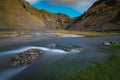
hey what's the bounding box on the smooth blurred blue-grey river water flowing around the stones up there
[0,36,120,80]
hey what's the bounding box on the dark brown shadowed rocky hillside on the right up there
[66,0,120,31]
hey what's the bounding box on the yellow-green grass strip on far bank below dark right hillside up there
[48,30,120,37]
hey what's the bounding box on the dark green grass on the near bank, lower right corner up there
[59,44,120,80]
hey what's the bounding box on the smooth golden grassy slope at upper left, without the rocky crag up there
[0,0,45,30]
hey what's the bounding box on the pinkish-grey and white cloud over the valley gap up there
[47,0,97,13]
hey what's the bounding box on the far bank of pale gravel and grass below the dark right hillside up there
[47,30,120,37]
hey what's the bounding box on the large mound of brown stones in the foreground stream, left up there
[11,49,43,66]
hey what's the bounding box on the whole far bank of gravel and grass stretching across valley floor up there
[0,30,120,47]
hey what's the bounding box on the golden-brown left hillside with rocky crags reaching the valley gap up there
[0,0,71,31]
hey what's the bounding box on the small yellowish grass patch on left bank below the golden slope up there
[0,31,25,38]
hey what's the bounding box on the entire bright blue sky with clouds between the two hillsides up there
[26,0,96,17]
